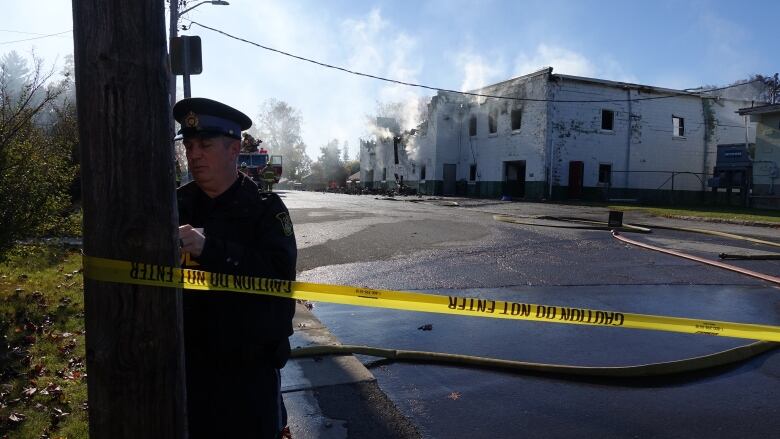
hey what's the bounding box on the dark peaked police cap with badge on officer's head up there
[173,98,252,140]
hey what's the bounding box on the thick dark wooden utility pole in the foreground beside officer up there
[73,0,187,439]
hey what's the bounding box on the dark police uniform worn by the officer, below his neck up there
[177,173,297,438]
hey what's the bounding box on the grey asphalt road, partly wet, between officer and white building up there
[282,192,780,438]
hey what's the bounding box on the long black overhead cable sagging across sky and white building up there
[189,20,757,103]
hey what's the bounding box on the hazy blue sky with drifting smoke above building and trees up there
[0,0,780,158]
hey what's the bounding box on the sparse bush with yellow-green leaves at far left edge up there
[0,52,77,257]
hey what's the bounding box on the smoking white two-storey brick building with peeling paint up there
[361,68,755,201]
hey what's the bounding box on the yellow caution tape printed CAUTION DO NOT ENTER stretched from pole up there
[84,256,780,342]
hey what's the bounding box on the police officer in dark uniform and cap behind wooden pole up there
[173,98,297,438]
